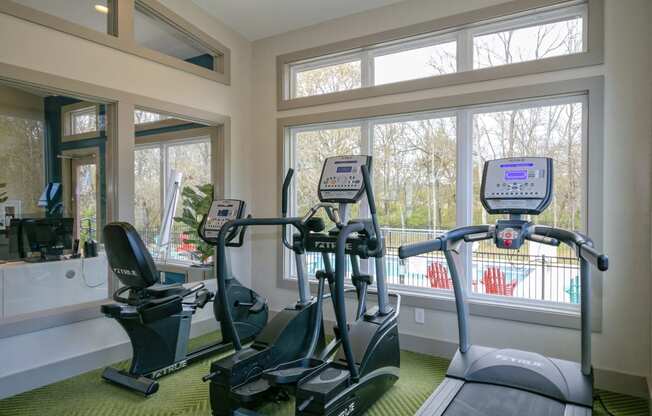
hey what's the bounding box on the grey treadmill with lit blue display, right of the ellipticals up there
[399,157,608,416]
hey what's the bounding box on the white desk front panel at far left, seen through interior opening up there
[0,253,109,319]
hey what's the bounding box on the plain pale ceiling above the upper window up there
[193,0,404,40]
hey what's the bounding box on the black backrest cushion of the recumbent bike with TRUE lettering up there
[104,222,160,289]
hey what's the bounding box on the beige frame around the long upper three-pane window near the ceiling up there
[276,0,604,111]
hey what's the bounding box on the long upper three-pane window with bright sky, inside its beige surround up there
[280,0,589,103]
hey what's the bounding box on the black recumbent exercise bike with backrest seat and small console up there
[101,200,268,396]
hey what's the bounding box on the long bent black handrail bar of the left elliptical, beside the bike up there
[217,217,301,351]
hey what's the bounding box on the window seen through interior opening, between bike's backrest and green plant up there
[134,137,212,262]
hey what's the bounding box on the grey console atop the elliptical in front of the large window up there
[317,155,371,204]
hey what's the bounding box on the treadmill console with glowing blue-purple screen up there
[480,157,552,215]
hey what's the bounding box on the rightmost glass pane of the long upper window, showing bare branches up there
[473,17,583,69]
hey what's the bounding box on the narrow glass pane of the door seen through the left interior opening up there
[77,164,97,247]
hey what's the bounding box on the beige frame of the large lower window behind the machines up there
[277,77,604,332]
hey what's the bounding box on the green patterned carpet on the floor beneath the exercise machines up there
[0,335,648,416]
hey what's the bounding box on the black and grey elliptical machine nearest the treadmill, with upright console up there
[295,156,401,416]
